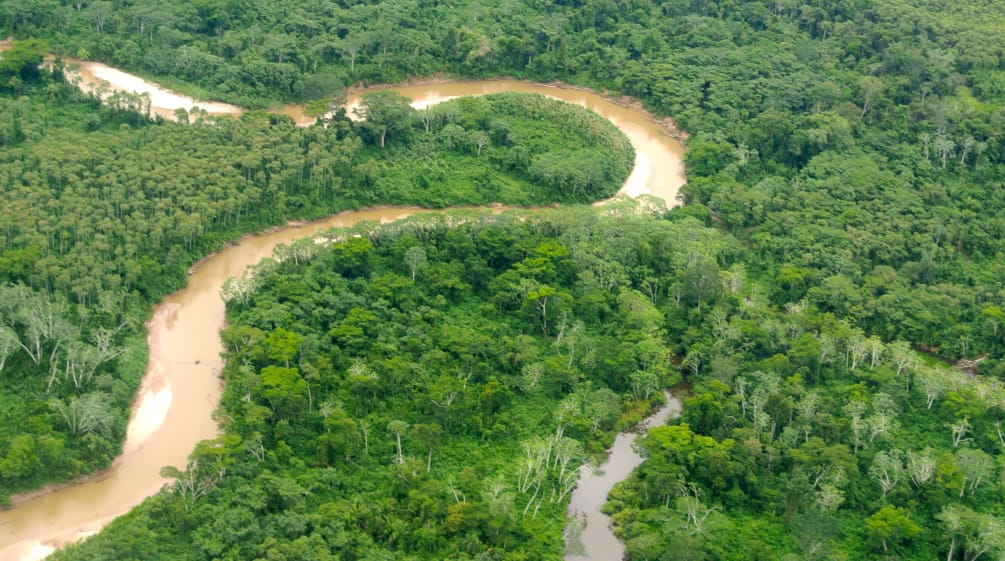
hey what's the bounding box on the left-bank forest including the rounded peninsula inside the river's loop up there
[0,65,632,496]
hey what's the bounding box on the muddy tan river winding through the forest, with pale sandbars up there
[0,53,684,561]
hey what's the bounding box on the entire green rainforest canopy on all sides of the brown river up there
[0,0,1005,561]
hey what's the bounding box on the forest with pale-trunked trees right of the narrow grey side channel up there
[607,267,1005,561]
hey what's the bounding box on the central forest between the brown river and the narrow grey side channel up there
[56,204,735,561]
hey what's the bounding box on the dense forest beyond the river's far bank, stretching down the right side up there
[2,0,1005,370]
